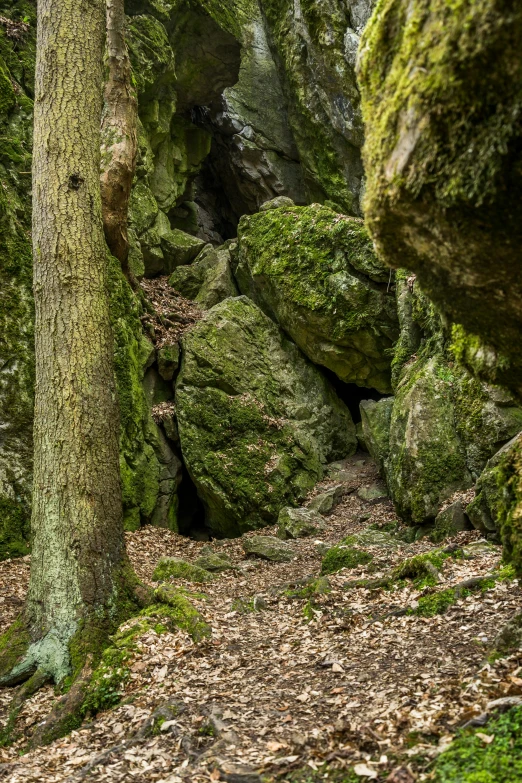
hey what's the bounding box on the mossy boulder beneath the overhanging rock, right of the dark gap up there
[361,275,522,525]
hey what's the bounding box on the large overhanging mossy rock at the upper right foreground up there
[359,0,522,396]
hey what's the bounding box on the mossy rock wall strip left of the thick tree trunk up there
[0,1,36,559]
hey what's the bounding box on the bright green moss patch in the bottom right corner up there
[433,707,522,783]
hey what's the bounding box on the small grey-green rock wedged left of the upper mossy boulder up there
[169,246,239,310]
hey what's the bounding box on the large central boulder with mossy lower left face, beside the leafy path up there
[176,297,356,536]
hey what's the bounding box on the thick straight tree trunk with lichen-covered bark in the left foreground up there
[23,0,126,682]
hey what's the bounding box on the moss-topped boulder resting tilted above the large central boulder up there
[235,204,399,392]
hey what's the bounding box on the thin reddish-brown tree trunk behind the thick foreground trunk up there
[100,0,138,283]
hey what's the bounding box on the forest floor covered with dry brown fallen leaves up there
[0,454,522,783]
